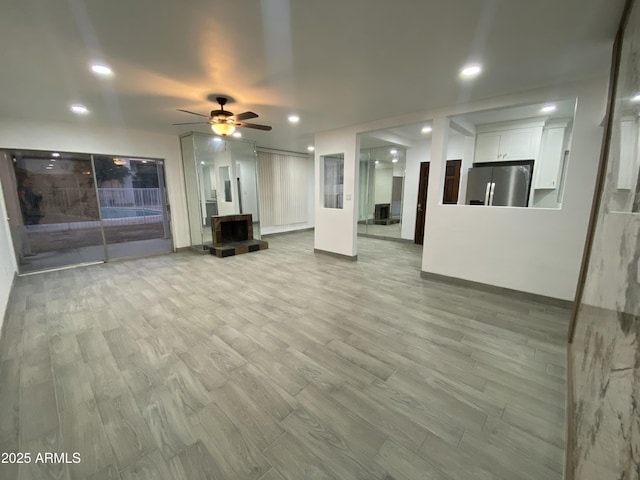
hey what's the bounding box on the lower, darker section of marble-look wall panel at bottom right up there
[570,305,640,480]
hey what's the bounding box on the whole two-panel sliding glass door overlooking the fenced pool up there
[0,150,173,274]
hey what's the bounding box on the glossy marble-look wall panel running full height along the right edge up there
[568,2,640,480]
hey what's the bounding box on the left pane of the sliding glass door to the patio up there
[2,150,105,273]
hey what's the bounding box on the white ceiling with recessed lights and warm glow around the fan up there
[0,0,624,151]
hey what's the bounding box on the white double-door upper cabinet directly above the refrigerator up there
[475,126,542,163]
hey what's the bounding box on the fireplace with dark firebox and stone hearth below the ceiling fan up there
[209,213,269,257]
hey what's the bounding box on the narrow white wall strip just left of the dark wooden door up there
[400,139,431,240]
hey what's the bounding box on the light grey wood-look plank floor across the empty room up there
[0,232,568,480]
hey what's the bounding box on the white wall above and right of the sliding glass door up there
[0,118,190,248]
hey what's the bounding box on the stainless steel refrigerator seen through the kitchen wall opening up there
[466,160,533,207]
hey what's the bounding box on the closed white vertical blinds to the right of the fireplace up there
[258,151,313,227]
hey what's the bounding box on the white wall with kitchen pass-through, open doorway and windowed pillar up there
[316,77,607,300]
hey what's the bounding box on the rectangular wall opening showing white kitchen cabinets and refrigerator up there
[442,99,576,208]
